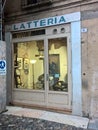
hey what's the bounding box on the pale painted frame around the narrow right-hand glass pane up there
[45,33,72,109]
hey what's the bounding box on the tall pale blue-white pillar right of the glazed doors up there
[71,21,82,116]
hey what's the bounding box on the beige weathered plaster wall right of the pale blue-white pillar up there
[81,18,98,117]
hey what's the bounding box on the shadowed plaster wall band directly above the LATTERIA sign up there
[4,0,98,25]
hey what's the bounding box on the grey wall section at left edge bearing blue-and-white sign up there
[0,41,6,113]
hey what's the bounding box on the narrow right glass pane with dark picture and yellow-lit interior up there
[48,38,68,91]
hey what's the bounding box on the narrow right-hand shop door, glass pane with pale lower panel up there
[47,37,71,109]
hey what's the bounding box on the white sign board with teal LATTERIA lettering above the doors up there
[12,12,80,31]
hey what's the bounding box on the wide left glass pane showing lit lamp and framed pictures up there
[14,40,44,90]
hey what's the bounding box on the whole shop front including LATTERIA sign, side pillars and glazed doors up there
[5,12,82,115]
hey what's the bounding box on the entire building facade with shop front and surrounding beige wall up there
[5,0,98,117]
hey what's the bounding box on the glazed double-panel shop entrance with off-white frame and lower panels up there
[12,34,71,110]
